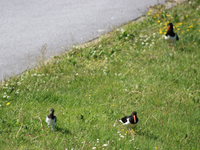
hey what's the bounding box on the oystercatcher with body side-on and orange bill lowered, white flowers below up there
[113,111,139,129]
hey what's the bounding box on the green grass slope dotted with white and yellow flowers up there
[0,0,200,150]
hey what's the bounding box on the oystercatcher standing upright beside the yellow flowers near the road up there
[165,22,179,52]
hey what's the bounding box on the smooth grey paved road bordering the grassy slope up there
[0,0,165,80]
